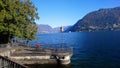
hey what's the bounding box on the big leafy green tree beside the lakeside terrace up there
[0,0,39,43]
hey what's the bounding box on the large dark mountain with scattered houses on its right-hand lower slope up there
[67,7,120,32]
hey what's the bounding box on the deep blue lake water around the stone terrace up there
[28,31,120,68]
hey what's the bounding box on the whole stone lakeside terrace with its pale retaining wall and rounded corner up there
[0,43,72,64]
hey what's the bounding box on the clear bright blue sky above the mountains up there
[31,0,120,28]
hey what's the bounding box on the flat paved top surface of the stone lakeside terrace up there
[11,47,72,56]
